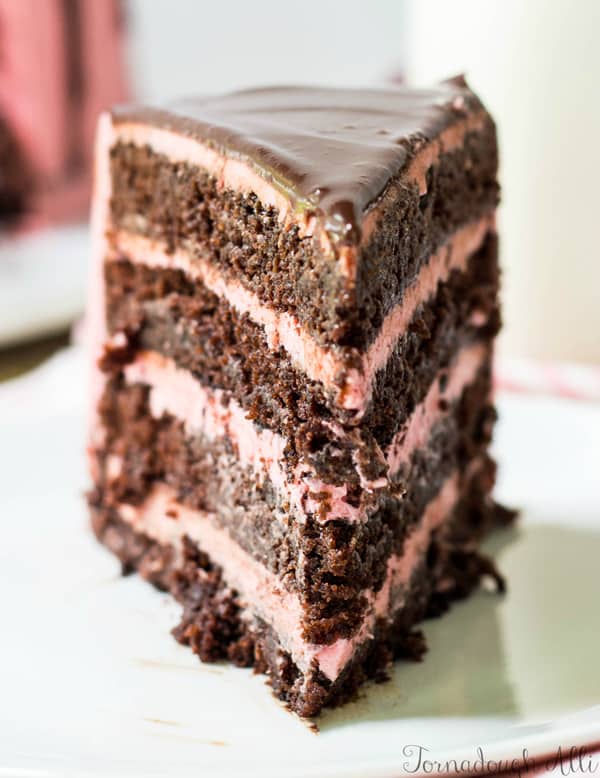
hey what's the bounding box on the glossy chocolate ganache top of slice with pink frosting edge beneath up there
[112,77,491,246]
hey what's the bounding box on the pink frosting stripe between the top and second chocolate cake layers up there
[107,215,494,415]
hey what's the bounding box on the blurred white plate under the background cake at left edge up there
[0,224,89,347]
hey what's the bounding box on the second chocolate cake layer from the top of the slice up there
[104,233,500,442]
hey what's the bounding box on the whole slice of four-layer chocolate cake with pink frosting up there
[90,79,510,716]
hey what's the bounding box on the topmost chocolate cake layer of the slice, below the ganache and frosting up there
[111,113,498,348]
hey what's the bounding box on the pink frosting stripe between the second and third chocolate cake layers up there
[124,343,489,521]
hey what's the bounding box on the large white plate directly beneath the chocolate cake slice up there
[0,351,600,778]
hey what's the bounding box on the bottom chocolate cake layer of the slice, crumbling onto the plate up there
[92,460,503,716]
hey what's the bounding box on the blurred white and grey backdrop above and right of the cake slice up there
[129,0,600,361]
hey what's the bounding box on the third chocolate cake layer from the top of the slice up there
[92,352,494,643]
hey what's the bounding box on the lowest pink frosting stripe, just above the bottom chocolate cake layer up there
[119,466,458,681]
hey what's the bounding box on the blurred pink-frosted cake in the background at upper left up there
[0,0,126,231]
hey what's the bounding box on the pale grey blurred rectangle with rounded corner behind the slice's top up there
[128,0,406,100]
